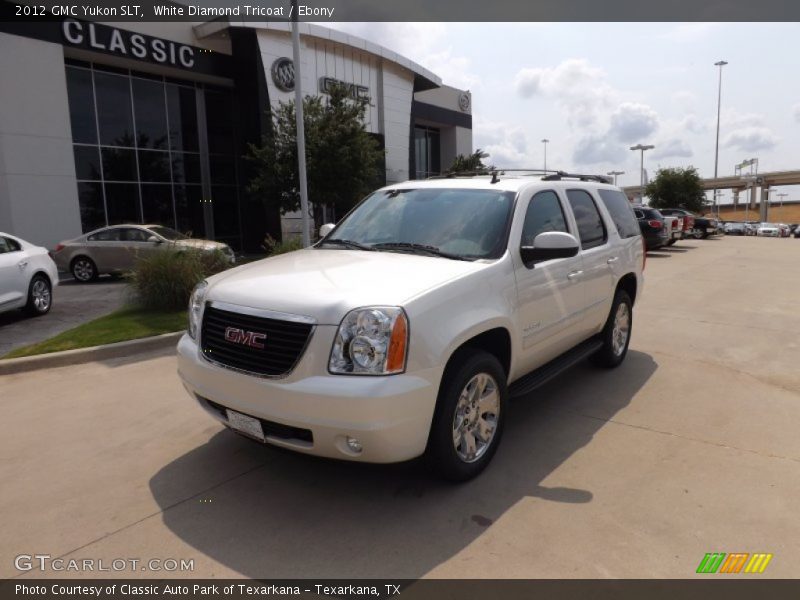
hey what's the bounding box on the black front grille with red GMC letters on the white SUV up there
[201,306,313,377]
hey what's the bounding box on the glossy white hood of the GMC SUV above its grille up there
[206,248,492,325]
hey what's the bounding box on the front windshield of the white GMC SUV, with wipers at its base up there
[326,188,514,259]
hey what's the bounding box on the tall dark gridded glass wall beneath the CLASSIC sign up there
[66,61,242,249]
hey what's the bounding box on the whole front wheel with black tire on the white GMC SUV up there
[427,349,508,481]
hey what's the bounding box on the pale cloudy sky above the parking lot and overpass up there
[326,23,800,202]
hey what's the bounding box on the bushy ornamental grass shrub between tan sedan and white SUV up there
[127,250,231,310]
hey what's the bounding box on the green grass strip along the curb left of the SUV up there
[3,307,187,358]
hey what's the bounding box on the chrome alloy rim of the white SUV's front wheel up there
[453,373,500,463]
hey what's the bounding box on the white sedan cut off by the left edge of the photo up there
[0,231,58,316]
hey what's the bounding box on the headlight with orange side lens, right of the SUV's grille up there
[328,306,408,375]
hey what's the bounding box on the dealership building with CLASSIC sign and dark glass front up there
[0,15,472,251]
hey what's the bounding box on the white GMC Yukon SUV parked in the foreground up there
[178,172,645,480]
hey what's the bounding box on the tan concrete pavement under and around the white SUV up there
[0,238,800,578]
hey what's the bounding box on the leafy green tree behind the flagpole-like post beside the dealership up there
[248,84,384,233]
